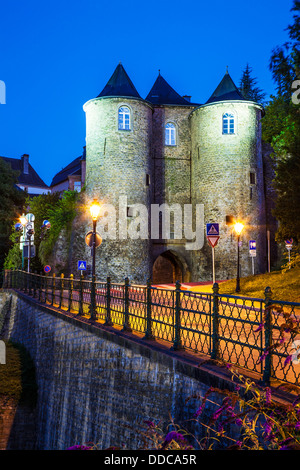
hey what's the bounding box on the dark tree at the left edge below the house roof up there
[0,158,27,270]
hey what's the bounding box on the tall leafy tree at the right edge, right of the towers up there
[262,0,300,243]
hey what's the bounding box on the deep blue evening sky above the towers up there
[0,0,293,184]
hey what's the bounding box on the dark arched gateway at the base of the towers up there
[152,250,190,284]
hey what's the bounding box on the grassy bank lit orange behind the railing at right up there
[219,266,300,302]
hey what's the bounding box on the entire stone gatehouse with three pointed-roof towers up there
[84,64,266,284]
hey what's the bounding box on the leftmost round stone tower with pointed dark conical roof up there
[84,64,152,283]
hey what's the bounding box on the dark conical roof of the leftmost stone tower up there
[97,62,141,98]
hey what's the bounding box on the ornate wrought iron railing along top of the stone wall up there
[3,270,300,385]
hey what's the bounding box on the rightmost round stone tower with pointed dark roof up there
[191,71,266,279]
